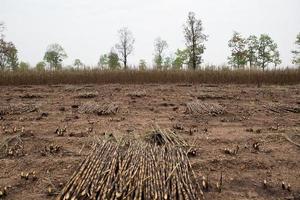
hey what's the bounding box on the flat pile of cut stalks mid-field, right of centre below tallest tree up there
[186,100,225,115]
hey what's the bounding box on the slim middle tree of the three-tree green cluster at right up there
[247,35,258,68]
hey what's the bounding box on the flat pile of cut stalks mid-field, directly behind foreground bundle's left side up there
[78,102,119,115]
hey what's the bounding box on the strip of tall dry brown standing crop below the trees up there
[0,69,300,85]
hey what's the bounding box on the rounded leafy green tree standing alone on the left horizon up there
[44,44,67,70]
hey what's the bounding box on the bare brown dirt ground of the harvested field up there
[0,84,300,200]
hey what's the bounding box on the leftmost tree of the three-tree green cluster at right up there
[228,32,247,68]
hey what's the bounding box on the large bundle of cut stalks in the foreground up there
[57,140,203,200]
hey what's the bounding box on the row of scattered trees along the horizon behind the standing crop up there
[0,12,300,71]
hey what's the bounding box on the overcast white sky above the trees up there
[0,0,300,66]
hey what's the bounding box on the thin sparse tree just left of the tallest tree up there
[154,38,168,69]
